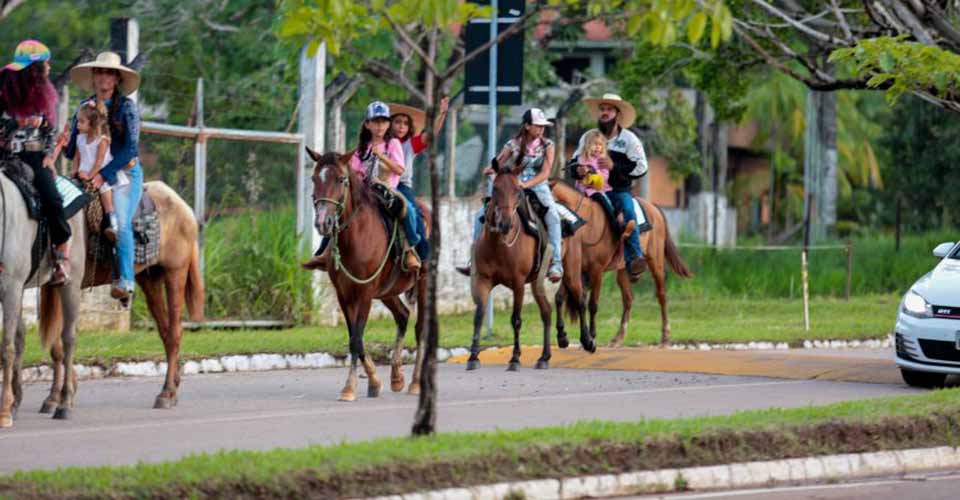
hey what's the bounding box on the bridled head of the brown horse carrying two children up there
[307,147,355,236]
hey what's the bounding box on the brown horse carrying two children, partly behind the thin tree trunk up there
[307,148,431,402]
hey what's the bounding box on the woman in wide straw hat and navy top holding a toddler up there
[65,52,143,301]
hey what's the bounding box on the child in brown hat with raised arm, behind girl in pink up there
[390,97,450,259]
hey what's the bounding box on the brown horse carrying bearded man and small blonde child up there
[552,181,693,347]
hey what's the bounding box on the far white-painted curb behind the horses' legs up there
[21,337,893,382]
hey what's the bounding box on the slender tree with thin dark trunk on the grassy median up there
[278,0,731,435]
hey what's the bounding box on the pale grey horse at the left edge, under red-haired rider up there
[0,163,86,428]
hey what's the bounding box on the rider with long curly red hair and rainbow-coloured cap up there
[0,40,70,286]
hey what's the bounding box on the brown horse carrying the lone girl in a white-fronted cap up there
[467,168,596,371]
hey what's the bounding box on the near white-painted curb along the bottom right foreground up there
[360,446,960,500]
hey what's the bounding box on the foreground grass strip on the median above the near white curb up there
[0,389,960,497]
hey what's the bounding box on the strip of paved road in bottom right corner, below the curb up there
[634,472,960,500]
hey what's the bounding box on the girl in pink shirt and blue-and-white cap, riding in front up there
[303,101,420,270]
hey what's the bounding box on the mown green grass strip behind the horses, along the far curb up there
[18,294,899,366]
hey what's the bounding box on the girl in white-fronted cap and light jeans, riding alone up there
[457,108,563,283]
